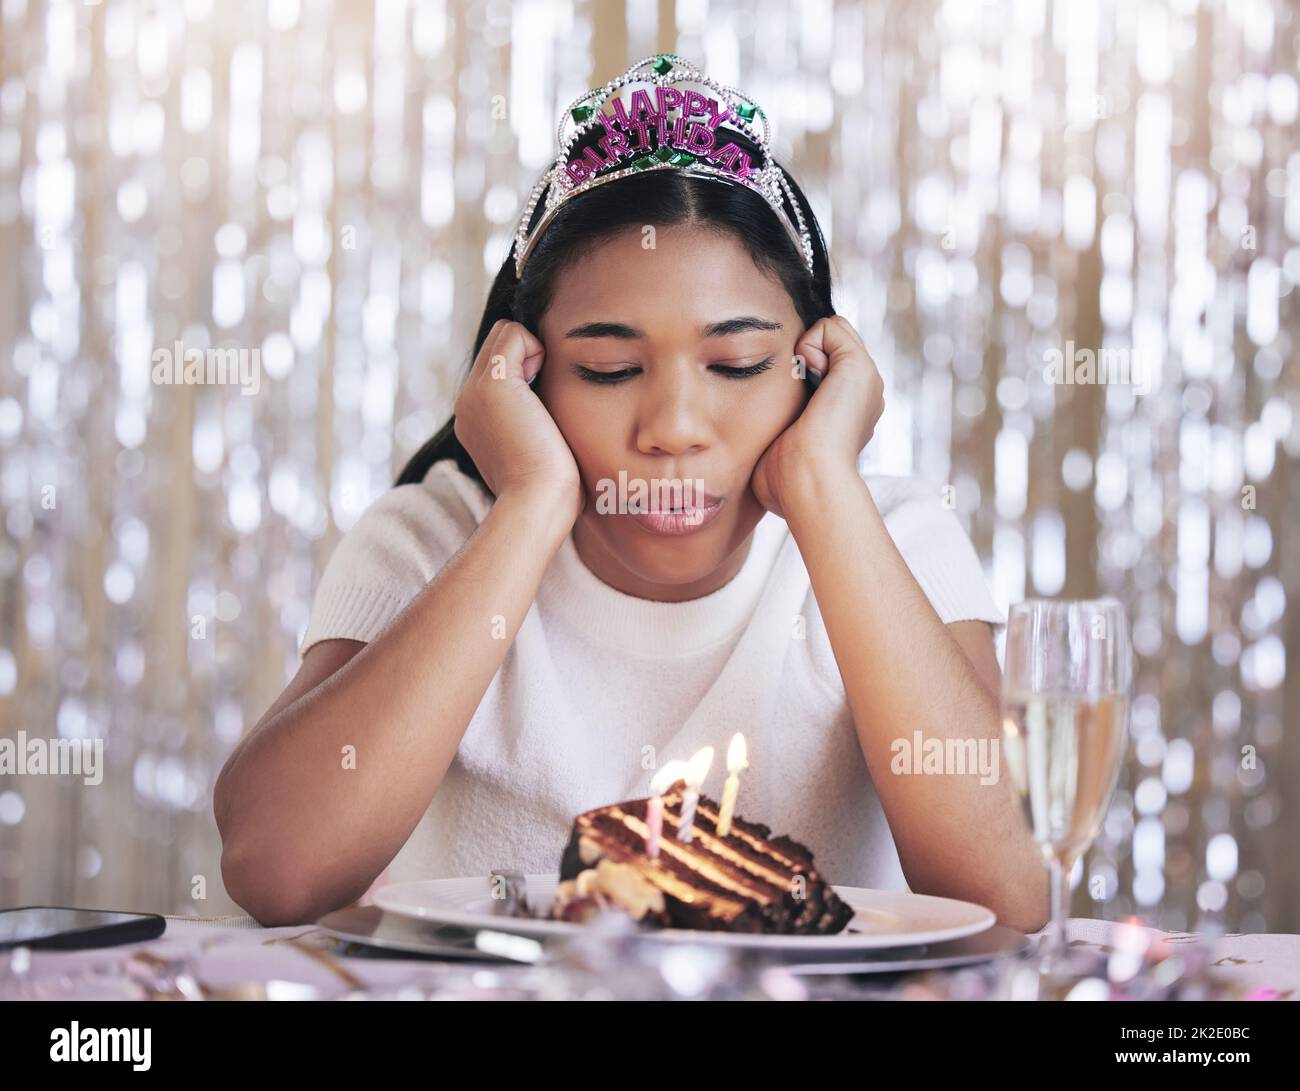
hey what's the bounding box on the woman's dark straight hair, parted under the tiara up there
[397,133,835,494]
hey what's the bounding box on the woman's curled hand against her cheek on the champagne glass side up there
[750,315,885,519]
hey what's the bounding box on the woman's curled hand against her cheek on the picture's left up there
[452,319,584,521]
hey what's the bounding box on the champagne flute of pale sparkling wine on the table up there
[1002,597,1132,971]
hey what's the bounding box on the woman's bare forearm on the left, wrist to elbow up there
[218,493,571,923]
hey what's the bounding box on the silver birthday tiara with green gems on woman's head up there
[515,53,813,277]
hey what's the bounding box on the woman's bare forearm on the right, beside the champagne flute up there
[788,468,1047,927]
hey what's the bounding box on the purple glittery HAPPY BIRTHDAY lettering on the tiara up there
[564,87,753,185]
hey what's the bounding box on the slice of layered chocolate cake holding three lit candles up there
[554,780,853,935]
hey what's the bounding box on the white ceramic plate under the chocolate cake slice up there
[374,875,997,952]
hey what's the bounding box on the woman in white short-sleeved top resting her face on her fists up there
[215,57,1047,930]
